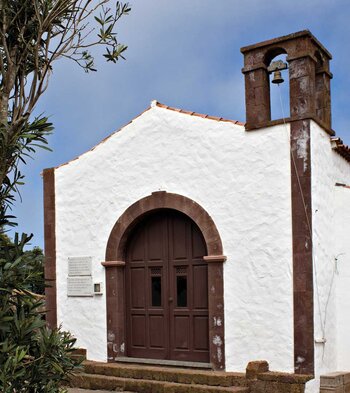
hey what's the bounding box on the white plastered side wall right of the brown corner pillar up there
[307,122,350,392]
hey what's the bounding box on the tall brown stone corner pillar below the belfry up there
[290,120,314,374]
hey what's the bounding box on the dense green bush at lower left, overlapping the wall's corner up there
[0,234,77,393]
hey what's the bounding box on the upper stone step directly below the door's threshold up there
[84,361,247,387]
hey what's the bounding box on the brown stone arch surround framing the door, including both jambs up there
[102,191,226,370]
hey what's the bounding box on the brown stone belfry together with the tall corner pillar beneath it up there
[241,30,334,374]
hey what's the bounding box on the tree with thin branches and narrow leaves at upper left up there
[0,0,130,228]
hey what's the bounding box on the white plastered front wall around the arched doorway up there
[55,106,293,372]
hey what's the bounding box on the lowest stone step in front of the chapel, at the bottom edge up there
[70,373,249,393]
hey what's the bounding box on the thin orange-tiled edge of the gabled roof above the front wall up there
[55,100,245,169]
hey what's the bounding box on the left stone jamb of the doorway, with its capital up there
[101,261,125,362]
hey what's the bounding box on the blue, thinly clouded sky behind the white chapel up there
[10,0,350,246]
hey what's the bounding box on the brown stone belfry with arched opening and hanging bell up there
[241,30,333,134]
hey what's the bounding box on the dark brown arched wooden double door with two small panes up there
[125,209,209,362]
